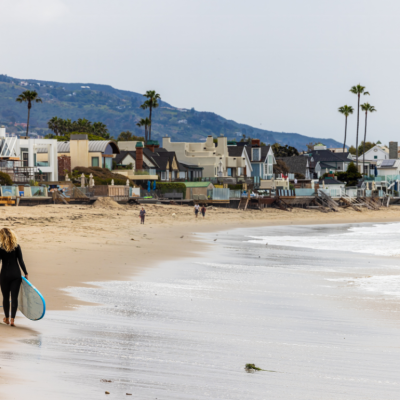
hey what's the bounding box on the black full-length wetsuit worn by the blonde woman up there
[0,245,28,318]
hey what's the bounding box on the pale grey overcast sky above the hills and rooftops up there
[0,0,400,142]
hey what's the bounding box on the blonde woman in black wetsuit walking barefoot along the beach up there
[0,228,28,326]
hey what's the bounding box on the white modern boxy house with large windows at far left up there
[0,126,58,184]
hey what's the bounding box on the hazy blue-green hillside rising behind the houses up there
[0,75,341,150]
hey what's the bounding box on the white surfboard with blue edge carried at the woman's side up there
[18,277,46,321]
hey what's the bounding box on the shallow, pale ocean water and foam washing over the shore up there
[0,224,400,400]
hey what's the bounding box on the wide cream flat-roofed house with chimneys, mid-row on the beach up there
[162,135,252,178]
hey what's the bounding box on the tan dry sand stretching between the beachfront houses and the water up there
[0,199,400,344]
